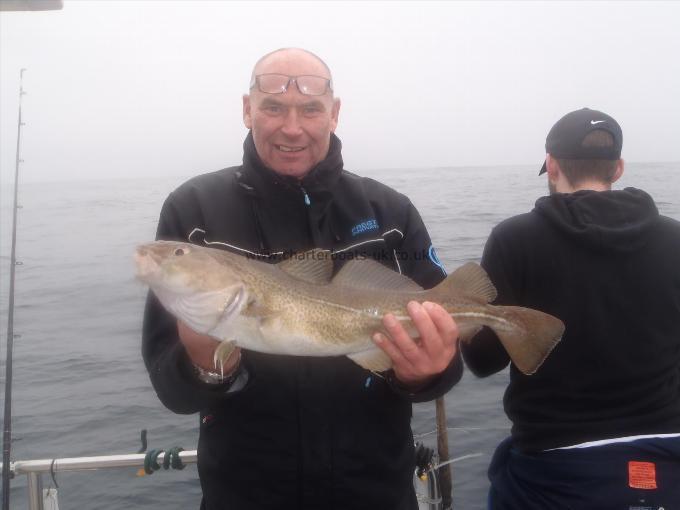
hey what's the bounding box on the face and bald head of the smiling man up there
[243,50,340,179]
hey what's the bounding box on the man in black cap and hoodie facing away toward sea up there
[461,108,680,510]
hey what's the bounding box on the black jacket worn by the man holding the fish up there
[143,135,462,510]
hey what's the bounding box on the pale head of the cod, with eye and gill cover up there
[135,241,248,334]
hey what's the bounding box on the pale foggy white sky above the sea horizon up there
[0,0,680,186]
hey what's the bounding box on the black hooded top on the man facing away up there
[462,188,680,451]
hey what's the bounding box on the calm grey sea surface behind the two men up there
[0,163,680,510]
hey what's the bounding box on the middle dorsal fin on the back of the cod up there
[333,258,423,292]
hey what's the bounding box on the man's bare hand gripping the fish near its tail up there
[373,301,458,388]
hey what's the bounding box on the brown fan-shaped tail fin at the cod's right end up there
[493,306,564,375]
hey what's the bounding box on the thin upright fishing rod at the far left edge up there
[2,69,26,510]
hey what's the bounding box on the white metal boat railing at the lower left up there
[3,450,197,510]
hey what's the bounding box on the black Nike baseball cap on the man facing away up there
[538,108,623,175]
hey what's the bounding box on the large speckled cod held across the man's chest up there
[135,241,564,374]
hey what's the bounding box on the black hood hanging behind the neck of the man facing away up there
[534,188,659,252]
